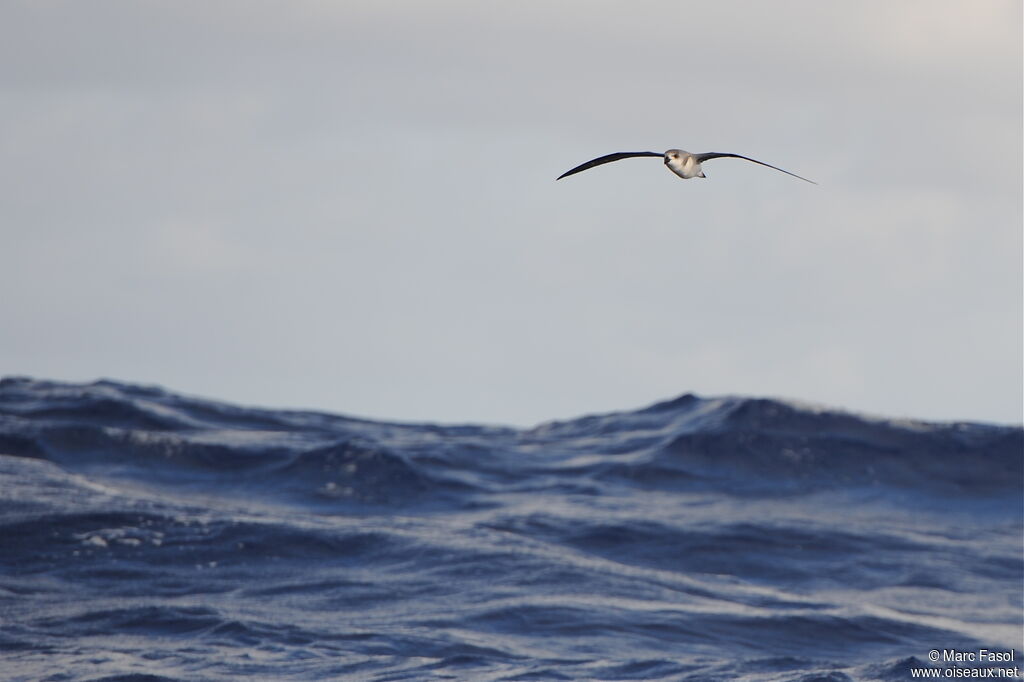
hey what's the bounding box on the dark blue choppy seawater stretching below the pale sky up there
[0,378,1024,682]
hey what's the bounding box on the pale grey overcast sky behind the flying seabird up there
[0,0,1022,425]
